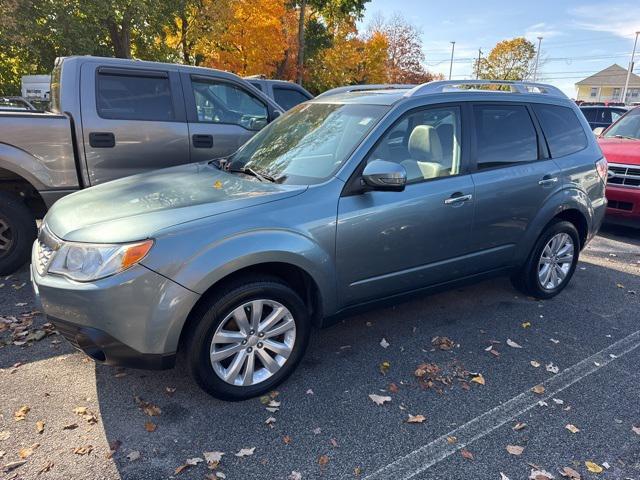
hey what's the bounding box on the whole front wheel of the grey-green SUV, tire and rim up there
[185,277,311,400]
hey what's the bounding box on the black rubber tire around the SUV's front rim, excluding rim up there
[183,277,311,401]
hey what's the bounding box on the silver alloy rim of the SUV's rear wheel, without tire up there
[538,233,575,290]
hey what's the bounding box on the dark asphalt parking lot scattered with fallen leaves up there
[0,227,640,480]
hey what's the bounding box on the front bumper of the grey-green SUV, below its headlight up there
[31,256,199,369]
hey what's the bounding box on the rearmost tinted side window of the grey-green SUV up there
[533,104,588,158]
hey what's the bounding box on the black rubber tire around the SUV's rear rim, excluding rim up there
[511,220,580,300]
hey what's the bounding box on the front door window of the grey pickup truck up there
[191,80,268,130]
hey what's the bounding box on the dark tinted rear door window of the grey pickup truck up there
[96,72,175,122]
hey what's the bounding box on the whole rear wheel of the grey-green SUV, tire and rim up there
[511,220,580,299]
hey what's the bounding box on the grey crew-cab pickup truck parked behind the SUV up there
[0,56,282,274]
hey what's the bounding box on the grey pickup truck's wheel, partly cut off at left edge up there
[0,192,38,275]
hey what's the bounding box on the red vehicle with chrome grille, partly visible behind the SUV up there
[598,107,640,227]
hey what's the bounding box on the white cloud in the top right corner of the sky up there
[569,3,640,38]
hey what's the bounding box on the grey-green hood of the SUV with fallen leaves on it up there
[45,162,307,243]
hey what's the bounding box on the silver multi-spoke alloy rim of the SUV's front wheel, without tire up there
[209,299,296,386]
